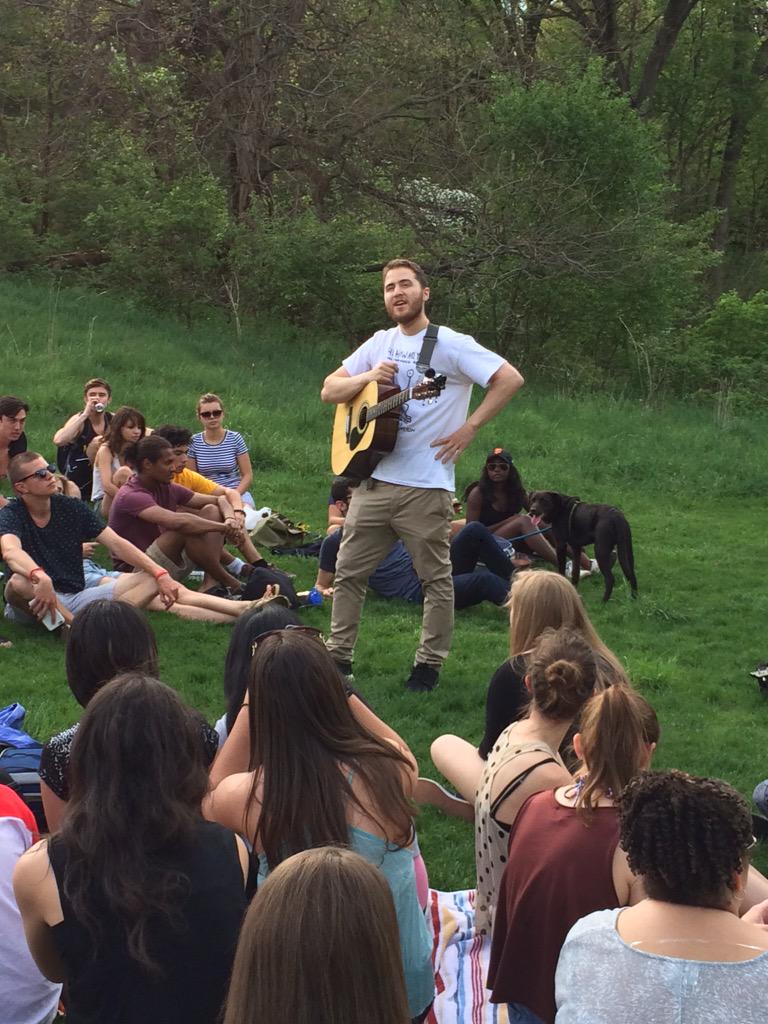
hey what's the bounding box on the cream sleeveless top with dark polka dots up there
[475,722,567,935]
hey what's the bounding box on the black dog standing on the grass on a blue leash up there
[528,490,637,601]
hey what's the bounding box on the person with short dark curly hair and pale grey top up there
[556,771,768,1024]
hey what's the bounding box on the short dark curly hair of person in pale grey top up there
[617,771,752,907]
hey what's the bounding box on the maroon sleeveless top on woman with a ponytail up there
[487,790,620,1024]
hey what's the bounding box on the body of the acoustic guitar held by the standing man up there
[331,381,400,480]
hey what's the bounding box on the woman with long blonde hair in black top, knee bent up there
[417,571,630,821]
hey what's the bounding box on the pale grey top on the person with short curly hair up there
[555,909,768,1024]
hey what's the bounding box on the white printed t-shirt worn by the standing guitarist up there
[342,327,505,492]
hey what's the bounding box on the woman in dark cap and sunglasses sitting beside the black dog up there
[464,447,557,565]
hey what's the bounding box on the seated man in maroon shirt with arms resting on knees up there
[110,434,242,590]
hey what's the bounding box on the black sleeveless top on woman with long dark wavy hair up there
[48,819,246,1024]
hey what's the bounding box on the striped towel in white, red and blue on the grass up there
[427,889,509,1024]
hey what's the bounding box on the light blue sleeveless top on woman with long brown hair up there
[258,825,434,1017]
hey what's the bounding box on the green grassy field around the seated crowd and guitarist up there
[0,279,768,888]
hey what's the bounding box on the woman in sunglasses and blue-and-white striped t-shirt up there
[187,393,254,508]
